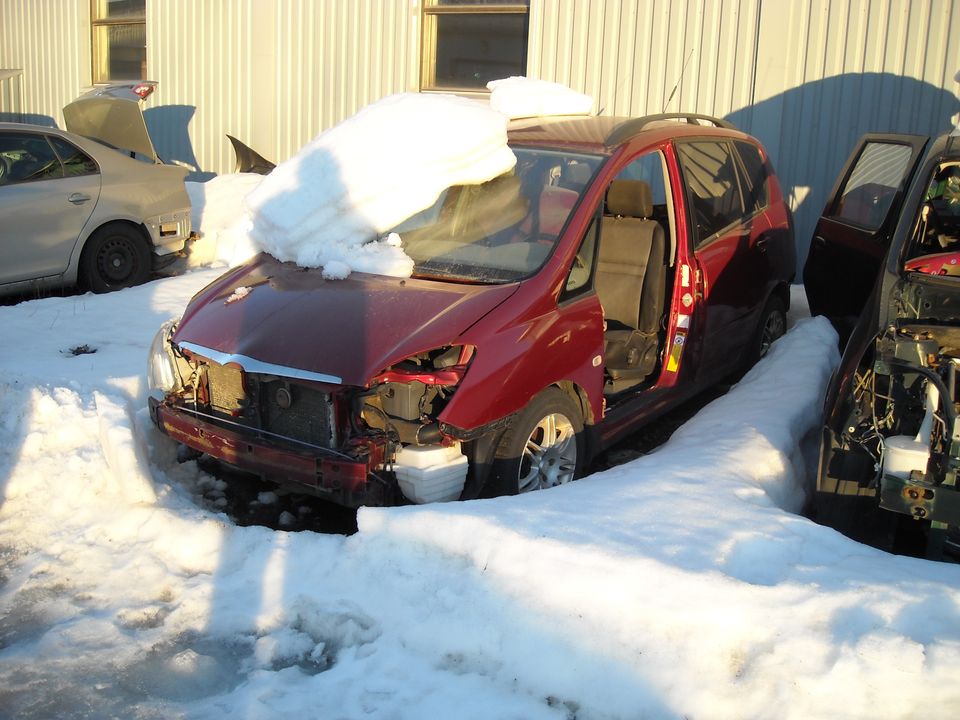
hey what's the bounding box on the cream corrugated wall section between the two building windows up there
[146,0,419,179]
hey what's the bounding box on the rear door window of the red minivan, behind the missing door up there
[677,140,744,246]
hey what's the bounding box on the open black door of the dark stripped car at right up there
[803,134,928,328]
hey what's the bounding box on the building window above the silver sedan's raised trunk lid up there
[90,0,147,84]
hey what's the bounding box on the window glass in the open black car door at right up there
[830,142,913,230]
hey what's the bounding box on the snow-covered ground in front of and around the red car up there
[0,270,960,720]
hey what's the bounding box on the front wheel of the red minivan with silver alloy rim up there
[488,387,585,495]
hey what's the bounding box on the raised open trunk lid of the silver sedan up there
[63,95,159,162]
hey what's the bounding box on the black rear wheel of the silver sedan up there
[79,225,151,293]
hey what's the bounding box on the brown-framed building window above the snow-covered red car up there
[420,0,530,91]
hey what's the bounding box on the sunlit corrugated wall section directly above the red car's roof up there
[528,0,760,115]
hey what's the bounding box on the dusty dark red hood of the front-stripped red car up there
[173,254,518,386]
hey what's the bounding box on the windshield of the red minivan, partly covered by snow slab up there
[395,148,603,283]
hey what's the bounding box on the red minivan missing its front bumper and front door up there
[150,115,795,507]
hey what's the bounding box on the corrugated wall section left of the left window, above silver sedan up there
[0,0,90,127]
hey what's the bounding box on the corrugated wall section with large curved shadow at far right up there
[752,0,960,260]
